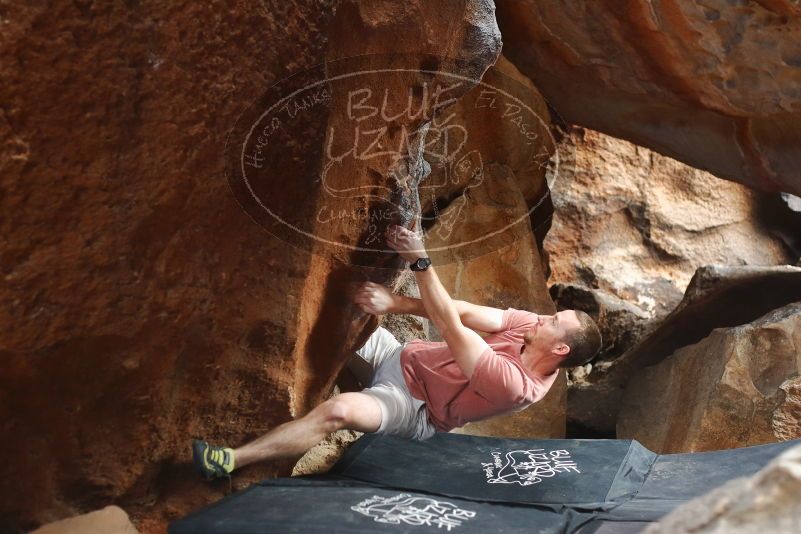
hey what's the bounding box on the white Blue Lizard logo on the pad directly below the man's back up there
[481,449,581,486]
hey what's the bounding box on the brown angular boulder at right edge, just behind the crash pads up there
[617,303,801,453]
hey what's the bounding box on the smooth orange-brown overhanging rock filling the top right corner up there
[497,0,801,195]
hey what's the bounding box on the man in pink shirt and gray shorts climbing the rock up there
[192,226,601,478]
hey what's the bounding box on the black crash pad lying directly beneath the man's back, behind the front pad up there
[332,433,657,510]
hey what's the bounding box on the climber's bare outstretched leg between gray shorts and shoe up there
[234,393,381,469]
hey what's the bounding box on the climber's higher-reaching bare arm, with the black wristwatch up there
[387,226,489,378]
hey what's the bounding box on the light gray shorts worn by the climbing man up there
[356,326,437,440]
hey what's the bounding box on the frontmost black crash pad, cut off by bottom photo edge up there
[169,477,570,534]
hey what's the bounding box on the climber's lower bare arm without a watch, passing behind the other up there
[354,282,503,333]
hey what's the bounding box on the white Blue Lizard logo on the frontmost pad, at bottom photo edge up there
[350,493,476,532]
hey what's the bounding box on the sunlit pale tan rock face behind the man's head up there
[545,128,801,319]
